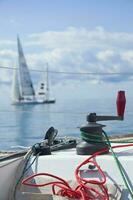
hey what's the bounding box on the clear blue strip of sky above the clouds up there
[0,0,133,37]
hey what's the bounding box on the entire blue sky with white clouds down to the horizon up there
[0,0,133,98]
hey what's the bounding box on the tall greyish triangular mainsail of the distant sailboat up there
[17,37,35,97]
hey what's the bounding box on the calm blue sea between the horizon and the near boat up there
[0,99,133,149]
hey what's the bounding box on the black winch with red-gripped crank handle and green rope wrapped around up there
[76,91,126,155]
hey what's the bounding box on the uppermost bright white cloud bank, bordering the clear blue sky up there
[27,27,133,50]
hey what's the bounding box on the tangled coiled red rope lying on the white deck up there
[22,144,133,200]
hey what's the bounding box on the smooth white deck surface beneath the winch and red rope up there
[32,147,133,200]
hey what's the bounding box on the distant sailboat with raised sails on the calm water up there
[12,37,55,104]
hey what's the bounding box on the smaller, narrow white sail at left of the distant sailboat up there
[12,70,21,102]
